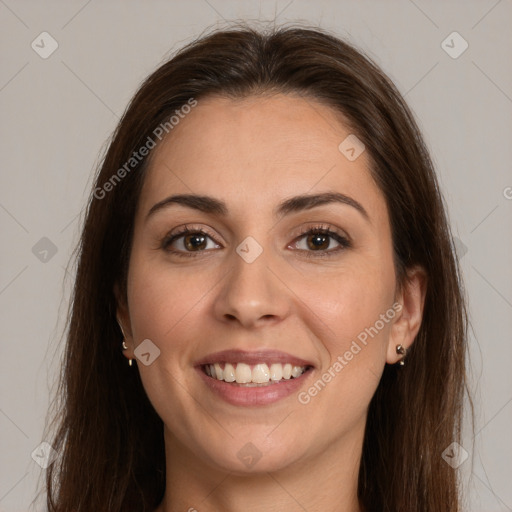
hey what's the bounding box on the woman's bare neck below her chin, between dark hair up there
[155,429,362,512]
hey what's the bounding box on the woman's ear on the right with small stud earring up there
[386,266,427,364]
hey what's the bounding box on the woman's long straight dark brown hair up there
[41,24,468,512]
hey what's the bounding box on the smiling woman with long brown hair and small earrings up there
[43,21,467,512]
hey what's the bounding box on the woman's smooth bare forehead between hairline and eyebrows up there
[139,94,386,226]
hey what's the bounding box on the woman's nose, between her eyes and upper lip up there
[214,241,291,329]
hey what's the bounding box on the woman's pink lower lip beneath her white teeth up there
[196,366,313,407]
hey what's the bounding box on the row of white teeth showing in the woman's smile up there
[201,363,313,387]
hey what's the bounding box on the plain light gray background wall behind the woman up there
[0,0,512,512]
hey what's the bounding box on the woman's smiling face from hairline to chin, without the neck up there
[119,95,410,473]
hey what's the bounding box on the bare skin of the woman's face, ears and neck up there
[116,94,426,512]
